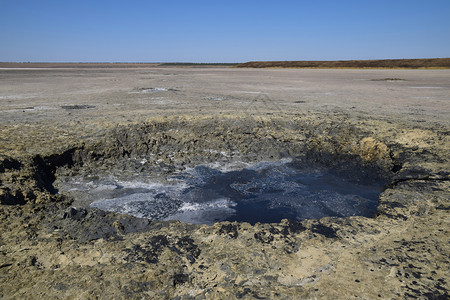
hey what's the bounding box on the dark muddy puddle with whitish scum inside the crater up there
[58,159,383,225]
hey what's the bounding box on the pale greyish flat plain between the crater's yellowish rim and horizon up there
[0,68,450,124]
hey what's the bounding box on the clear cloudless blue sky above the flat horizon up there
[0,0,450,63]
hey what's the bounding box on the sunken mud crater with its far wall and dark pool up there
[54,117,392,224]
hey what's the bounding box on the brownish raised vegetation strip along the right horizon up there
[236,58,450,69]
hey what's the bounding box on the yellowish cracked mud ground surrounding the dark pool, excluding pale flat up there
[0,115,449,299]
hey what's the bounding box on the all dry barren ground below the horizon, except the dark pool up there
[0,68,450,299]
